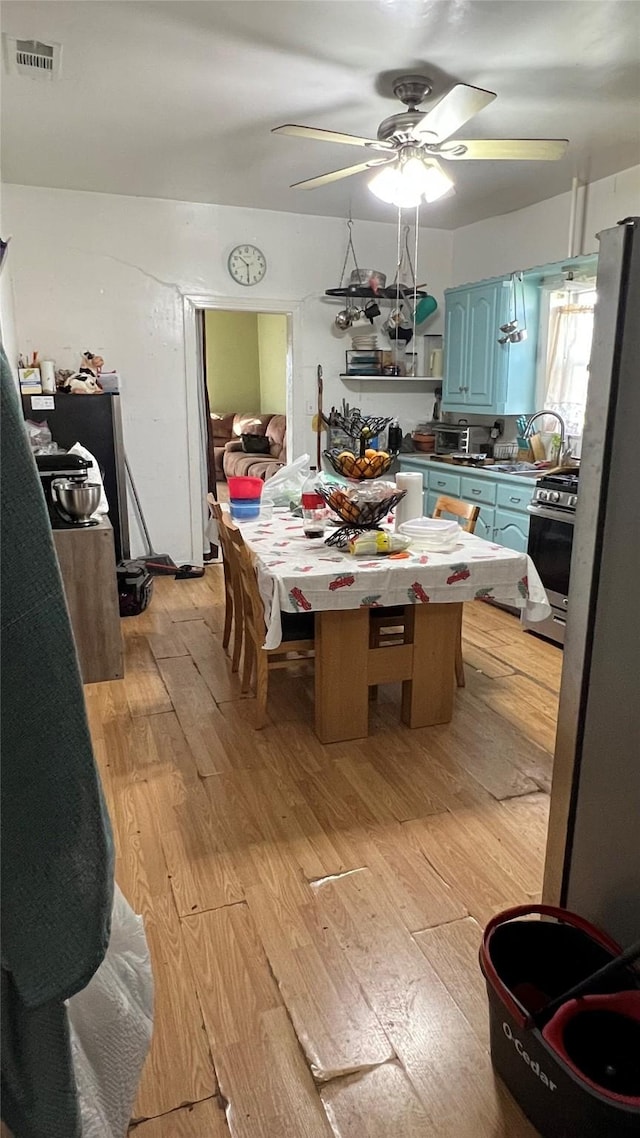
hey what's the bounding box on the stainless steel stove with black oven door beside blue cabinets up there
[527,473,579,644]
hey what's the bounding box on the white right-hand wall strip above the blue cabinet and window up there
[453,166,640,285]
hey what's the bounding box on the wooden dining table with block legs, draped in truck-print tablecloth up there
[226,510,551,743]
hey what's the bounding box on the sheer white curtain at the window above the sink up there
[544,292,596,435]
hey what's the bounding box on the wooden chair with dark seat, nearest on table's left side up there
[232,529,315,729]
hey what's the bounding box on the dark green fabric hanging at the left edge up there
[0,352,113,1138]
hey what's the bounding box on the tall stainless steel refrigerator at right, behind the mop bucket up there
[544,217,640,945]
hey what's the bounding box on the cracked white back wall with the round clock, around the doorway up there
[3,185,452,560]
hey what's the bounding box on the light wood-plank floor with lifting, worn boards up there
[85,566,561,1138]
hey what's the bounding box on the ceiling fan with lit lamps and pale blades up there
[272,75,568,206]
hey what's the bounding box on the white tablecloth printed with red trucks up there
[234,512,551,648]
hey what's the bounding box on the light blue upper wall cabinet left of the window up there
[442,277,540,415]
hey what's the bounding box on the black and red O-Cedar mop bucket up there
[479,905,640,1138]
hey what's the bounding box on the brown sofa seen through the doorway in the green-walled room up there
[210,412,287,481]
